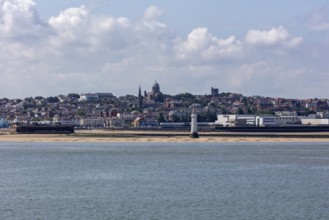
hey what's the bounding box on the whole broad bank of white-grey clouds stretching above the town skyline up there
[0,0,328,97]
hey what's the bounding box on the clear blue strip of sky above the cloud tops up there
[36,0,322,35]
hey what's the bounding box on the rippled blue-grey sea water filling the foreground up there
[0,143,329,220]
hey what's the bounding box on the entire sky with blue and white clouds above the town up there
[0,0,329,99]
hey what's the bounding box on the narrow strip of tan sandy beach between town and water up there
[0,130,329,143]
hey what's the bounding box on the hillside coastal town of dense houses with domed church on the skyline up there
[0,82,329,129]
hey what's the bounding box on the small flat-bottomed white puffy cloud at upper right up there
[245,26,303,47]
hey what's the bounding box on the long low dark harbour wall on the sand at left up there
[16,125,74,134]
